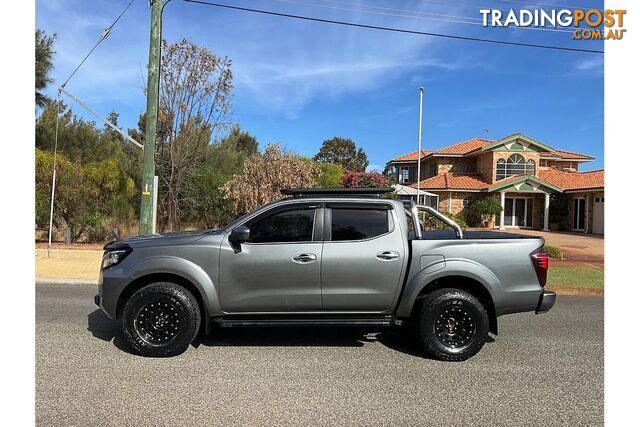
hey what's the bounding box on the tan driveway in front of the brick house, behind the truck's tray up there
[498,230,604,267]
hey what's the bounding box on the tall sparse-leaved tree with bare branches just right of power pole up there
[156,39,233,230]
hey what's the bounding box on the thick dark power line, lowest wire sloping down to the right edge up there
[183,0,604,54]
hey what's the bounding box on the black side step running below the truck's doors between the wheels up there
[212,316,399,328]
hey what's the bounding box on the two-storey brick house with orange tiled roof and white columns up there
[387,133,604,234]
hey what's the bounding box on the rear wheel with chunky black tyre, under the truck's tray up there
[416,288,489,361]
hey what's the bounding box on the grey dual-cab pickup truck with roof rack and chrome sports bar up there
[95,189,555,361]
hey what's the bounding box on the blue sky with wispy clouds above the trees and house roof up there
[36,0,604,170]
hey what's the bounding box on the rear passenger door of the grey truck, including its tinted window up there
[322,203,406,312]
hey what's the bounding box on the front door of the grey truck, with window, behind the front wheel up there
[219,204,322,312]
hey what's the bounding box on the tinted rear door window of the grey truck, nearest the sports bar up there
[331,208,389,241]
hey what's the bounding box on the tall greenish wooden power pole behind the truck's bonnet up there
[139,0,162,235]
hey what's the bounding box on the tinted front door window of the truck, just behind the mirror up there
[249,208,315,243]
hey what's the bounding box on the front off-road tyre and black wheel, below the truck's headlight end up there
[122,282,200,357]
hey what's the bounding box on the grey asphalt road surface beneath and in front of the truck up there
[36,285,604,426]
